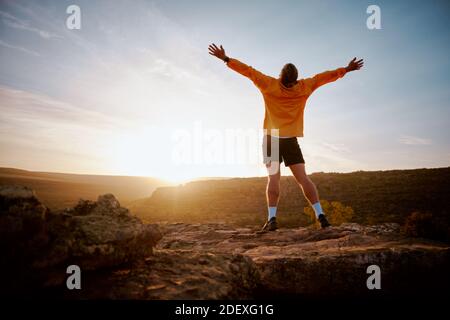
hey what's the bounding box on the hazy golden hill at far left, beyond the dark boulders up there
[0,168,167,209]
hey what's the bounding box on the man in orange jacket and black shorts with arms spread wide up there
[208,44,363,232]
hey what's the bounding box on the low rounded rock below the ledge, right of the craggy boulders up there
[79,250,260,300]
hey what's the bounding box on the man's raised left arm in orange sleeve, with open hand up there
[208,43,272,89]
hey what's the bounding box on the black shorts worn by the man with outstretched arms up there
[263,135,305,167]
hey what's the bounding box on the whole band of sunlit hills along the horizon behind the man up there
[0,168,450,241]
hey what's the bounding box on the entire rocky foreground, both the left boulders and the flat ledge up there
[0,188,450,299]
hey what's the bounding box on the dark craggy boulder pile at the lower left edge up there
[0,185,161,295]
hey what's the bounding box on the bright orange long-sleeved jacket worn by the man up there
[227,58,346,137]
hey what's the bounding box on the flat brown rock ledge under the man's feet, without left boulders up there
[79,224,450,299]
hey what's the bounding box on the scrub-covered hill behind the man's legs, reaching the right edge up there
[128,167,450,226]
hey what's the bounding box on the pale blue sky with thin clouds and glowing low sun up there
[0,0,450,181]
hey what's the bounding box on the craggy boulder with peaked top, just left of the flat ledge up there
[42,194,161,270]
